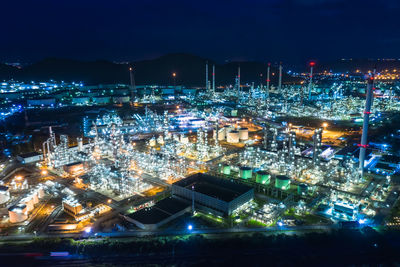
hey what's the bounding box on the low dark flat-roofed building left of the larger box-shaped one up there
[123,197,191,230]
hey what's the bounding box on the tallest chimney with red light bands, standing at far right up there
[359,74,375,176]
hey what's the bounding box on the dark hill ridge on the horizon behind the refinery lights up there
[0,54,290,86]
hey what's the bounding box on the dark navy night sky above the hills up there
[0,0,400,63]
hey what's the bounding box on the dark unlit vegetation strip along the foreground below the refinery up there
[0,228,400,266]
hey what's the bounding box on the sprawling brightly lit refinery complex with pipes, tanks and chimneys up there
[0,61,400,239]
